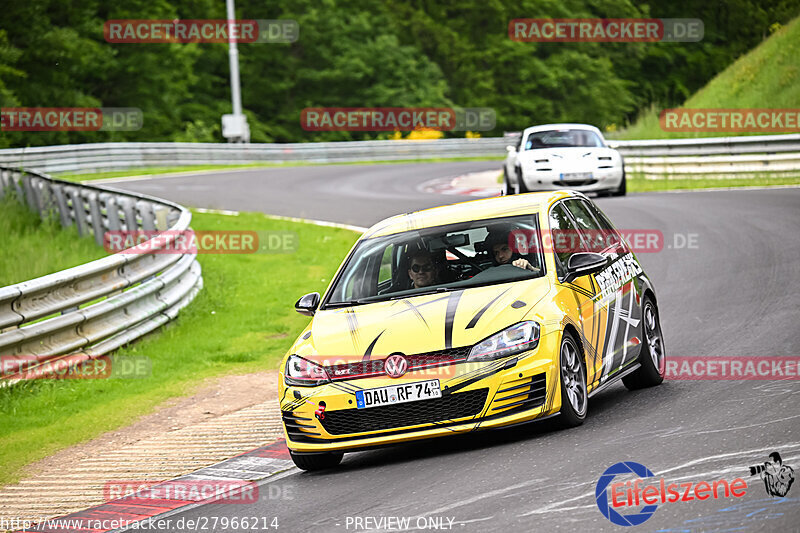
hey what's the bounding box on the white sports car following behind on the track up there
[503,124,625,196]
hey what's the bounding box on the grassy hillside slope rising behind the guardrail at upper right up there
[608,17,800,139]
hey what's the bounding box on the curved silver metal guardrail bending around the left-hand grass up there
[0,167,203,384]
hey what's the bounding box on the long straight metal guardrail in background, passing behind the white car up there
[0,134,800,177]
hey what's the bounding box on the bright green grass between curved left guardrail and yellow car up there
[0,213,358,484]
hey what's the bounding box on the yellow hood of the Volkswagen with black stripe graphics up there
[290,277,550,366]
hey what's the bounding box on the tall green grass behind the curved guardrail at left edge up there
[0,198,106,287]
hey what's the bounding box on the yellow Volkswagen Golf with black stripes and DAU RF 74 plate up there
[279,191,666,470]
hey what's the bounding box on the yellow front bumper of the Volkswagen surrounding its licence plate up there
[280,335,561,453]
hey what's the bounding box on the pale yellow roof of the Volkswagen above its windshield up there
[361,190,583,239]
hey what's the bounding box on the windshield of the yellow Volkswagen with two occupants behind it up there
[323,211,544,308]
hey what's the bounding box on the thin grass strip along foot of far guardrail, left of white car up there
[59,157,502,182]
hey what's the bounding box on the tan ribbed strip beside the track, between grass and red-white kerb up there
[0,372,282,520]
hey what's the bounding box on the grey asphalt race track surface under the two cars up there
[108,162,800,532]
